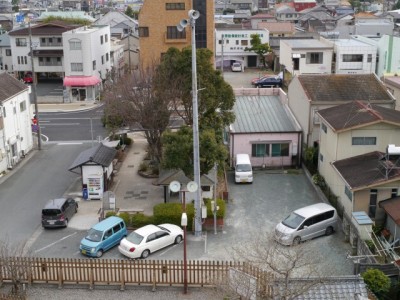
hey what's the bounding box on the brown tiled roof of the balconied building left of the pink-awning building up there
[9,21,81,36]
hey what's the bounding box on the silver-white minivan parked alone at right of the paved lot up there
[275,203,337,245]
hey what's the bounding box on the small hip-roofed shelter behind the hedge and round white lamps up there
[157,168,216,203]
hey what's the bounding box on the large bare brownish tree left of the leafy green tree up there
[105,68,172,163]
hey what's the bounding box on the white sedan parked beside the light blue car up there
[118,224,183,258]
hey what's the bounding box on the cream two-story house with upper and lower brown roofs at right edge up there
[317,101,400,230]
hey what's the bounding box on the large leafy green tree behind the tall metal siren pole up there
[155,48,235,138]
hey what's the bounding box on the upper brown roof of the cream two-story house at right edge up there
[318,101,400,131]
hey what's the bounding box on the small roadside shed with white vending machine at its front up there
[68,143,117,200]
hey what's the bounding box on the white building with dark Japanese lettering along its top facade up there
[215,28,269,67]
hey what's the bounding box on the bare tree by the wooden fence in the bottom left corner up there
[0,238,32,295]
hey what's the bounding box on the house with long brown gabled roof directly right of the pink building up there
[288,74,395,147]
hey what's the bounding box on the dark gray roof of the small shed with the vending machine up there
[68,143,117,171]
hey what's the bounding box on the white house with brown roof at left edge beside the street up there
[0,73,33,173]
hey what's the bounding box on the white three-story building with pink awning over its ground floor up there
[62,25,111,102]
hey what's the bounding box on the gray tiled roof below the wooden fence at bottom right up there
[274,275,368,300]
